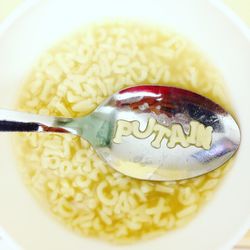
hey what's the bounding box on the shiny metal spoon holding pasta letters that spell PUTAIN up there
[0,85,240,181]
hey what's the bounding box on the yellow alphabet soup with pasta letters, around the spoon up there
[16,22,232,243]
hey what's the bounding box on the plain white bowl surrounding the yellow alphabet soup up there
[0,0,250,250]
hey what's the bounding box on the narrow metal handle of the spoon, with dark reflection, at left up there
[0,109,79,134]
